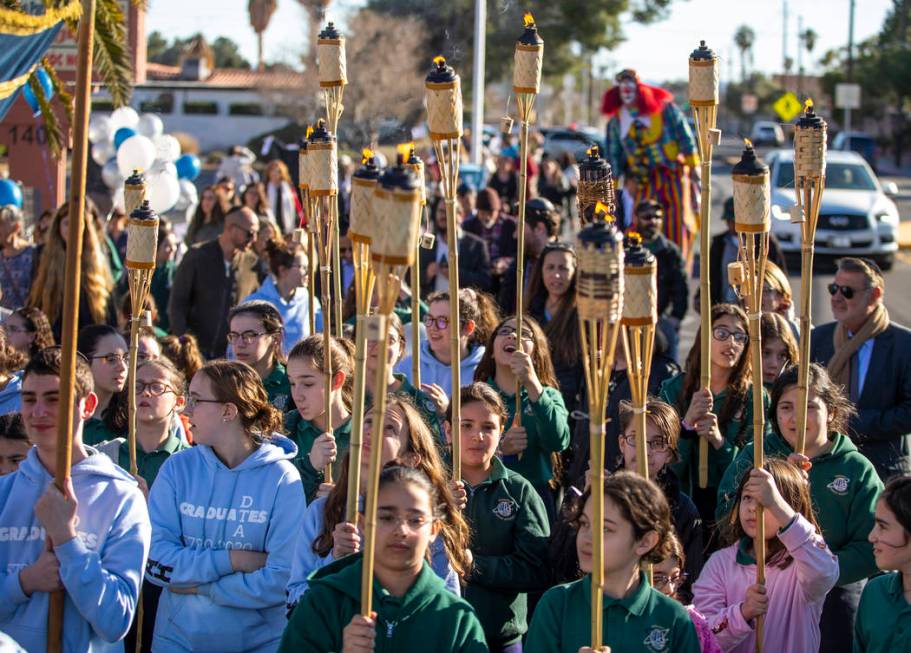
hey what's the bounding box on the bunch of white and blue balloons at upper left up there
[89,107,201,213]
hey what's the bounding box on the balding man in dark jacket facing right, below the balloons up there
[168,207,259,358]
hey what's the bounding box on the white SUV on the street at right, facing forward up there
[766,150,899,270]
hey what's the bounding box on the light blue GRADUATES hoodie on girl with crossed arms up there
[146,434,304,653]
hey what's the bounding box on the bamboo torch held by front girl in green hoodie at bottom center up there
[361,150,421,617]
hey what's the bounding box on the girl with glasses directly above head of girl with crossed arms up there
[228,300,294,412]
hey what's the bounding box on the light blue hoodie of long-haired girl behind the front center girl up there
[288,497,462,612]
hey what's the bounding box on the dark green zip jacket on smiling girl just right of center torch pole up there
[463,458,550,649]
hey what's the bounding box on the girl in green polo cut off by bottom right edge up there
[854,476,911,653]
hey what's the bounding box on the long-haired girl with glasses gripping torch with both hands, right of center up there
[660,304,768,535]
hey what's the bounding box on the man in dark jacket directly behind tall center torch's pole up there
[419,194,491,297]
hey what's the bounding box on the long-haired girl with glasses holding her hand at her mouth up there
[474,317,569,522]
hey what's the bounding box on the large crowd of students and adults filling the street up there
[0,134,911,653]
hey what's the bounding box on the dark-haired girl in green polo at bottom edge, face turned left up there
[525,471,700,653]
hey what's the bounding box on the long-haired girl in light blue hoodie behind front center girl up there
[288,395,471,609]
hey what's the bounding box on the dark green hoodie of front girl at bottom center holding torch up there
[278,553,487,653]
